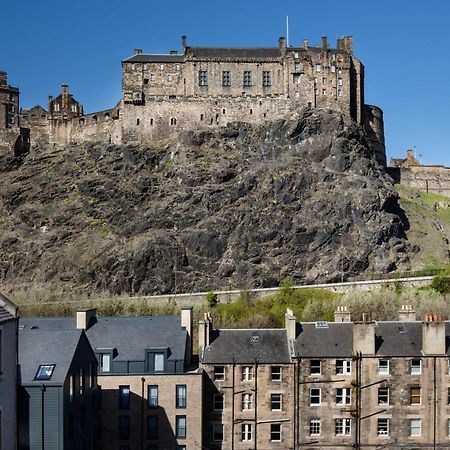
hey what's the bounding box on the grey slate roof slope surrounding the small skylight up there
[19,330,83,385]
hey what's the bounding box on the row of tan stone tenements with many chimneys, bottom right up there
[199,306,450,450]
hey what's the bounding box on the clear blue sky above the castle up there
[0,0,450,166]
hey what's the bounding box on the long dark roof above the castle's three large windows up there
[186,47,282,59]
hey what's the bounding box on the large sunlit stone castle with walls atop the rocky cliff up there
[0,36,386,165]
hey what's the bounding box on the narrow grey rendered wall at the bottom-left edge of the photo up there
[0,320,17,450]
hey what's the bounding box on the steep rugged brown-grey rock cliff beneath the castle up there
[0,109,408,294]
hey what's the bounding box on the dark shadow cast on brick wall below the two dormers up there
[98,384,178,450]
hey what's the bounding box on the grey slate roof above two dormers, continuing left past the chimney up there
[20,316,187,361]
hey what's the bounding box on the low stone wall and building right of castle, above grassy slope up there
[388,150,450,197]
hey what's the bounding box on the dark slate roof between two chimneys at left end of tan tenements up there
[203,329,290,364]
